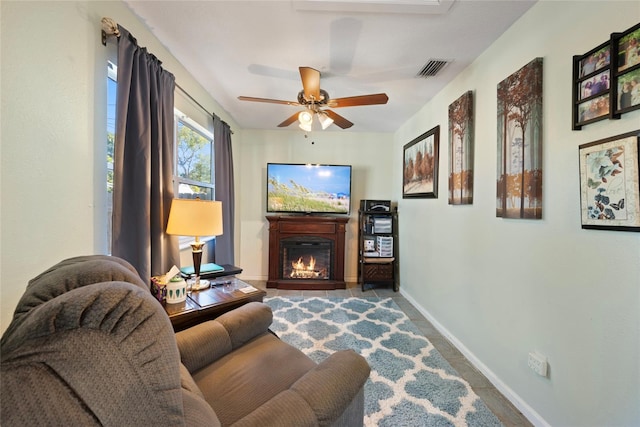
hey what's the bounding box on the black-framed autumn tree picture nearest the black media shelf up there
[402,126,440,199]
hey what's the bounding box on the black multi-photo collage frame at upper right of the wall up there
[572,24,640,130]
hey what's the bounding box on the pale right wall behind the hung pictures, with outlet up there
[393,1,640,426]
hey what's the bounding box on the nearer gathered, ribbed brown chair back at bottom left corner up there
[0,282,183,426]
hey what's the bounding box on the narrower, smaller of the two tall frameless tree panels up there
[449,91,474,205]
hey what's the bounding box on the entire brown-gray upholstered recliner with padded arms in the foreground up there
[0,256,369,427]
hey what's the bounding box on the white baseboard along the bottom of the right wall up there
[400,288,551,427]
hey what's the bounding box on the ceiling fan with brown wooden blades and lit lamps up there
[238,67,389,132]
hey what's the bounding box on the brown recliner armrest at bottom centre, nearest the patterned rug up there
[234,350,371,427]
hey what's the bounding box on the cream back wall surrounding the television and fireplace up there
[234,130,393,282]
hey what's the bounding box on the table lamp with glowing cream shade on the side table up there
[167,199,222,288]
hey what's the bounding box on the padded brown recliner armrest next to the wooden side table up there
[176,302,273,373]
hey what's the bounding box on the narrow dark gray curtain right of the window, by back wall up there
[213,116,235,265]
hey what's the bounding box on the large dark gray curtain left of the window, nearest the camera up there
[112,26,179,282]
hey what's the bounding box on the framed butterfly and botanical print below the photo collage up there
[579,130,640,232]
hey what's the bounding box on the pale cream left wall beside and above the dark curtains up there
[0,1,235,331]
